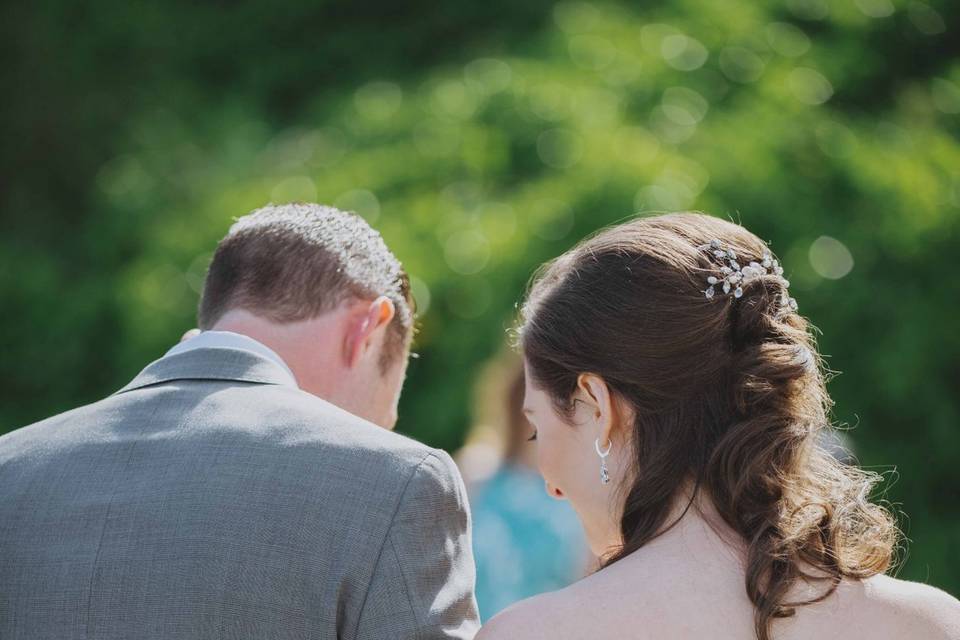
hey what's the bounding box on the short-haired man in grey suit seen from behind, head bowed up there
[0,204,477,640]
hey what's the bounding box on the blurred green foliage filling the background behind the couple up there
[0,0,960,593]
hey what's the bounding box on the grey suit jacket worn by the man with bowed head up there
[0,349,478,640]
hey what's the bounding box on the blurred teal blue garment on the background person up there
[470,464,588,621]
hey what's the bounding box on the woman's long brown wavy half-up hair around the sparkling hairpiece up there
[518,213,897,640]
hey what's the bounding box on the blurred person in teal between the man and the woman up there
[456,353,593,620]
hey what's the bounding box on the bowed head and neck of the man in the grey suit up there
[199,203,414,428]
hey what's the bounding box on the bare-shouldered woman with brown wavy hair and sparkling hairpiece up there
[478,213,960,640]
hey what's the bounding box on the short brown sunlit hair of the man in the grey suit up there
[198,203,414,368]
